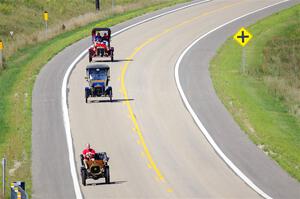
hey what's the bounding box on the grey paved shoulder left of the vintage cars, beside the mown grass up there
[32,3,209,199]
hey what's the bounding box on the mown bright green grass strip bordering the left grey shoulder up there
[0,0,189,195]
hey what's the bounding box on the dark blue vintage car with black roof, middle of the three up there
[85,64,112,103]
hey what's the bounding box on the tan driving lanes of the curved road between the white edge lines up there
[68,1,298,198]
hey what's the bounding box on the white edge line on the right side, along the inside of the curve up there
[175,0,289,199]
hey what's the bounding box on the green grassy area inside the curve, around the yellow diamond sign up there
[210,5,300,181]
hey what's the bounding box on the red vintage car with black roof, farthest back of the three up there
[89,28,114,62]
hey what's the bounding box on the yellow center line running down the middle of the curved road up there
[121,2,242,193]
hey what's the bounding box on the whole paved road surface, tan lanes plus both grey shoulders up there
[33,0,299,198]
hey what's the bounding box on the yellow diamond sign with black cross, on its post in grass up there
[233,27,253,74]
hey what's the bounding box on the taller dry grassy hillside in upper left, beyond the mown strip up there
[0,0,170,58]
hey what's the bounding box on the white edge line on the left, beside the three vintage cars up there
[61,0,212,199]
